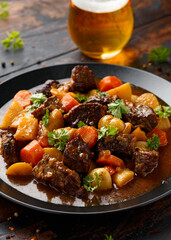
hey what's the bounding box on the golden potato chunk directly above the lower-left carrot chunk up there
[14,117,38,141]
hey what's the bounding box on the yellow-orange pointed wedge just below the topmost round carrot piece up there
[107,83,132,101]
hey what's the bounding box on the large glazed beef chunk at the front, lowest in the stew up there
[33,154,82,196]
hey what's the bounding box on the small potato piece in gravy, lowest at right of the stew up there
[112,168,134,188]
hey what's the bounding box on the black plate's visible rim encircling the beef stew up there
[0,63,171,214]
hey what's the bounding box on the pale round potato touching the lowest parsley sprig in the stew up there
[89,168,112,191]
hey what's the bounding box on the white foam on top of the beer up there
[72,0,129,13]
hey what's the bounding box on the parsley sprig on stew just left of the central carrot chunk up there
[47,128,70,151]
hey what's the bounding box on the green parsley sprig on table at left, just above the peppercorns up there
[1,31,24,50]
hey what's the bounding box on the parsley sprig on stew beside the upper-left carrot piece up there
[26,93,47,112]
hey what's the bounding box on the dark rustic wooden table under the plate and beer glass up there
[0,0,171,240]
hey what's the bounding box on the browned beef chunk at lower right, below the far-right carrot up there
[133,147,159,177]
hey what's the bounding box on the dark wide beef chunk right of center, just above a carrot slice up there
[97,134,135,158]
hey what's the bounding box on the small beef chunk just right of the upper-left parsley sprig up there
[32,96,62,120]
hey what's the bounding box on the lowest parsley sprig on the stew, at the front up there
[83,172,101,192]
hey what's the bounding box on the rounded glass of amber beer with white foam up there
[68,0,134,59]
